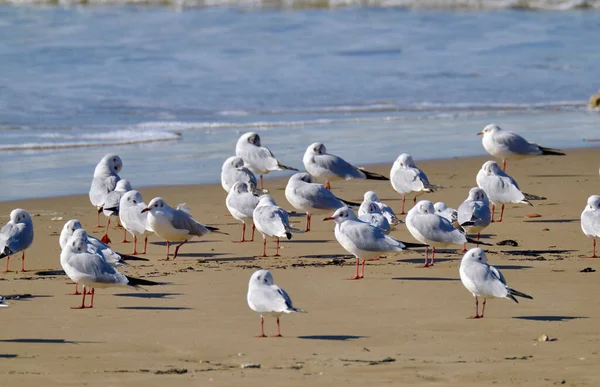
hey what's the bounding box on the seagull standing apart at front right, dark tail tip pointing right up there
[459,247,533,318]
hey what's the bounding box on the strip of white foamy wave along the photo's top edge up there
[0,0,600,11]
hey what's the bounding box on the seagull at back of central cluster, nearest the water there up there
[235,132,297,189]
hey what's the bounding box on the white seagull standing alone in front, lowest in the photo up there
[247,269,305,337]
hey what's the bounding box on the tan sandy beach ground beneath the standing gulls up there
[0,148,600,387]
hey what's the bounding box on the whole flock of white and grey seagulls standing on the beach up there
[0,125,600,336]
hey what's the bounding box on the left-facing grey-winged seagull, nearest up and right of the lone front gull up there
[323,207,424,280]
